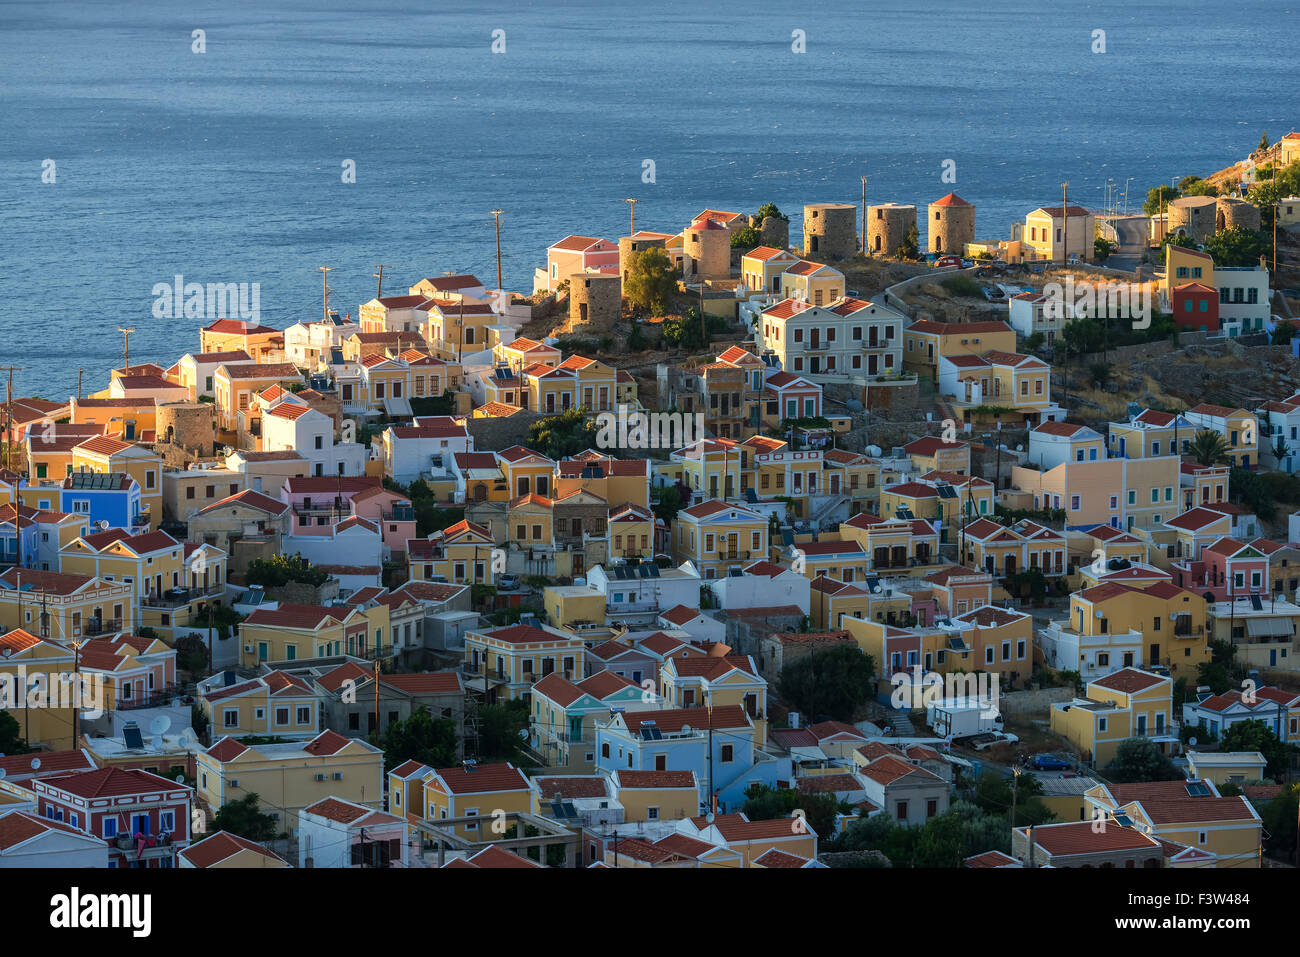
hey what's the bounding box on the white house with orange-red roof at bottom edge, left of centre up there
[298,797,413,867]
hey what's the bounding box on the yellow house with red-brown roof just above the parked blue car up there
[1050,668,1178,767]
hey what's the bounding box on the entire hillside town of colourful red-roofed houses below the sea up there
[0,133,1300,869]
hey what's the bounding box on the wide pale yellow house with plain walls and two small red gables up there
[195,731,384,833]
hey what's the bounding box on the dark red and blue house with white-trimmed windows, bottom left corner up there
[29,767,194,867]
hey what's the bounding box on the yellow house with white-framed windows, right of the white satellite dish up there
[198,671,324,739]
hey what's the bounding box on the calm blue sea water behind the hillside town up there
[0,0,1300,397]
